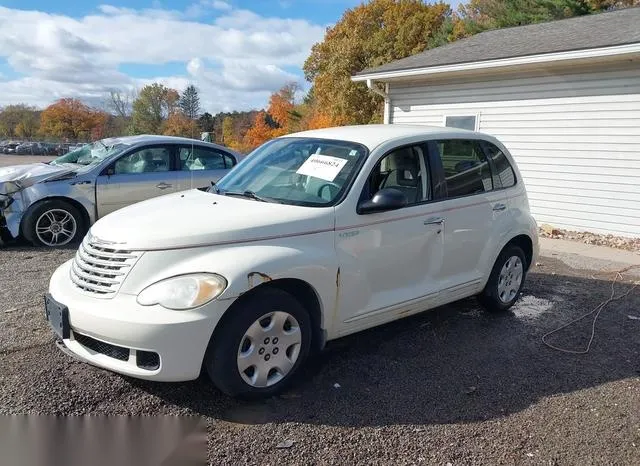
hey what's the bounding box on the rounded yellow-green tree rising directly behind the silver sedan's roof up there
[132,83,180,134]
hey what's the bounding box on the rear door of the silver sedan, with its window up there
[176,144,236,191]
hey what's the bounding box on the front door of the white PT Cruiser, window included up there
[335,145,443,335]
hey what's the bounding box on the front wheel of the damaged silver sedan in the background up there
[22,199,85,247]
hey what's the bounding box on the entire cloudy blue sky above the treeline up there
[0,0,460,113]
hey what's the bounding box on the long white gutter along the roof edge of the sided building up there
[351,43,640,82]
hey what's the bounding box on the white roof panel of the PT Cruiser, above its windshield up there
[281,124,494,150]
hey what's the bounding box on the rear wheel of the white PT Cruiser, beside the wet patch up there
[478,246,526,312]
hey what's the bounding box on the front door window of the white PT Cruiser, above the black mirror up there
[361,146,431,205]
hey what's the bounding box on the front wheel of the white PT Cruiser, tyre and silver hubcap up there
[205,289,311,398]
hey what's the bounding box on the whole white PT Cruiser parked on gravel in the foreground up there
[45,125,538,397]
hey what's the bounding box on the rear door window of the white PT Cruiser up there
[436,139,493,197]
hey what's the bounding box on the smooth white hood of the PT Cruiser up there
[89,190,334,250]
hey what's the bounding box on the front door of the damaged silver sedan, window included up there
[96,145,176,218]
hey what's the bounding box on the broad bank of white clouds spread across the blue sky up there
[0,0,324,112]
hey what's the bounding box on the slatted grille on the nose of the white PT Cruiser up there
[70,235,142,298]
